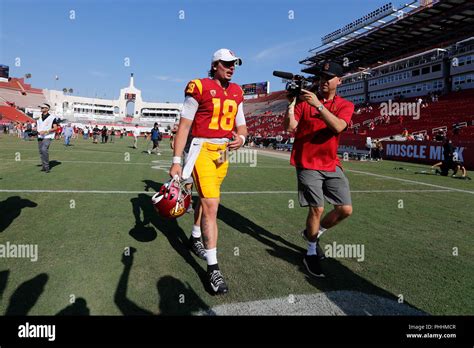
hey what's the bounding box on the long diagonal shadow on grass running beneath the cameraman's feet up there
[218,204,419,315]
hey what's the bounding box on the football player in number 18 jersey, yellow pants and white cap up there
[169,48,247,294]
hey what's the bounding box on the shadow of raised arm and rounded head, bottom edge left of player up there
[114,248,209,316]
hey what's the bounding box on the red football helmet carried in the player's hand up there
[151,178,191,219]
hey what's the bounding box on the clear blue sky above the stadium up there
[0,0,392,102]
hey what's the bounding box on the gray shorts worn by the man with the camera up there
[296,167,352,207]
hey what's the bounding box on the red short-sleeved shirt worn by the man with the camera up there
[290,96,354,172]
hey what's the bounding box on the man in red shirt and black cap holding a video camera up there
[283,62,354,277]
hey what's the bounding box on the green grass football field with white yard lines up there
[0,135,474,315]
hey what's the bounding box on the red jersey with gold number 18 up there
[184,78,244,139]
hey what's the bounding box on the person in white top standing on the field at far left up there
[37,103,58,173]
